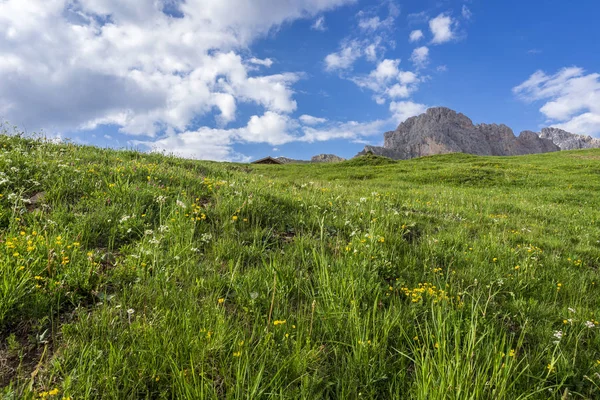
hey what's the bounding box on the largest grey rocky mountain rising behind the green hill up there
[359,107,560,160]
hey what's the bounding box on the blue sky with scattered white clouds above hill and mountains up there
[0,0,600,162]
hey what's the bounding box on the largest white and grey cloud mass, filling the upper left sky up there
[0,0,353,139]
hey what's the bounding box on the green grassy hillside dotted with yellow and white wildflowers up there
[0,136,600,399]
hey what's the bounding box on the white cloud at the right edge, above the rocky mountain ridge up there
[513,67,600,136]
